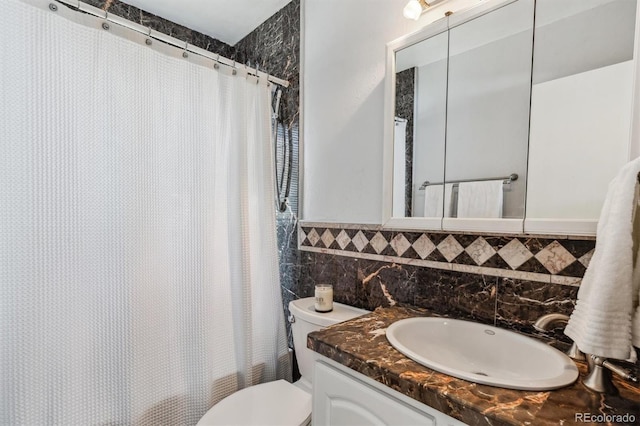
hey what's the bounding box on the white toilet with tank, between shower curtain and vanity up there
[197,297,369,426]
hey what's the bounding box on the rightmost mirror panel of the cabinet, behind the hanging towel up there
[525,0,637,234]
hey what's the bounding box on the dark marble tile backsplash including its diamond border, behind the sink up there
[298,222,595,341]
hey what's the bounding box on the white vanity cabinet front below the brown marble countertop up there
[312,359,464,426]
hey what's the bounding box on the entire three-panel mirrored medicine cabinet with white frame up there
[383,0,637,235]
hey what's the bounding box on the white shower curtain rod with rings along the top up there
[49,0,289,87]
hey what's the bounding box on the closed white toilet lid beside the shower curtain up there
[198,380,311,426]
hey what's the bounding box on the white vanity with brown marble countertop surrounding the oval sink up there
[307,306,640,426]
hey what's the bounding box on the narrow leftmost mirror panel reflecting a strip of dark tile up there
[393,32,449,220]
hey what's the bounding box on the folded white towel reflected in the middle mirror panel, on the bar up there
[458,180,504,218]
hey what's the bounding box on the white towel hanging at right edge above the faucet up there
[564,158,640,360]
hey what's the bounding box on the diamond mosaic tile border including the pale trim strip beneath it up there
[298,222,595,286]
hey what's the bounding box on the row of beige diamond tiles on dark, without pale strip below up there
[298,226,595,278]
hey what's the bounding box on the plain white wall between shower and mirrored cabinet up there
[301,0,479,223]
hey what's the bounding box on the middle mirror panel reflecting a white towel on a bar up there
[445,0,533,226]
